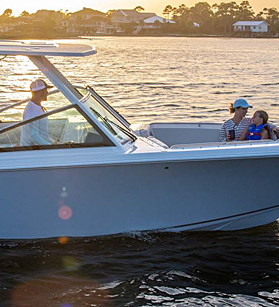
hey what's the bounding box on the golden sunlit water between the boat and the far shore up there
[0,37,279,123]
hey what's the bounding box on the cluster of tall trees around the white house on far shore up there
[163,1,279,35]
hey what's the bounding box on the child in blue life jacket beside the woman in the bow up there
[239,110,269,141]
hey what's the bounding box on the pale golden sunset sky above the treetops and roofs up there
[0,0,279,16]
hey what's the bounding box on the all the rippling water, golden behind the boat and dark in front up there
[0,38,279,307]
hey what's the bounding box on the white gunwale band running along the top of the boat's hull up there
[0,144,279,172]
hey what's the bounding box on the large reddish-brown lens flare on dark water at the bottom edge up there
[11,276,109,307]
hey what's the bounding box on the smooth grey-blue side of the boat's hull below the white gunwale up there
[0,158,279,239]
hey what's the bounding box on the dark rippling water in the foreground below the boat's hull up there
[0,227,279,307]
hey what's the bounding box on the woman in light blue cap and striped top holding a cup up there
[220,98,253,142]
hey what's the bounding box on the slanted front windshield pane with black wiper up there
[81,91,136,144]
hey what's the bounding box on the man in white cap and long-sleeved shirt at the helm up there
[20,79,53,146]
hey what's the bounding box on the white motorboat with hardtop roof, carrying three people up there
[0,42,279,239]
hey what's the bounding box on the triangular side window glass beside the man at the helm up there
[0,106,115,152]
